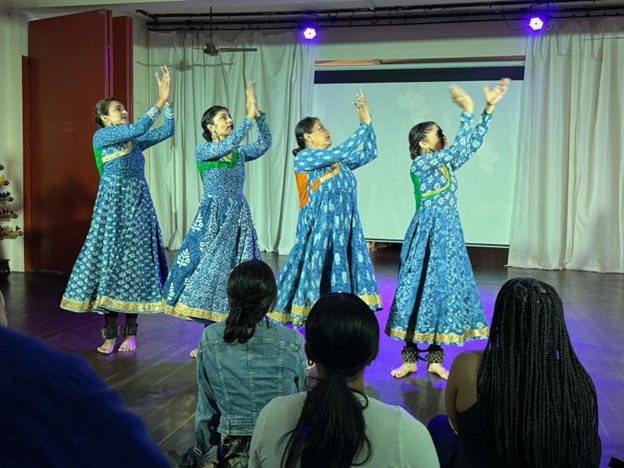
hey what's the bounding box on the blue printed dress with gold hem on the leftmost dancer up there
[61,106,174,314]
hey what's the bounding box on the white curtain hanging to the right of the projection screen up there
[509,18,624,272]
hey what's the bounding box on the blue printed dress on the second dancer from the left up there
[164,114,271,322]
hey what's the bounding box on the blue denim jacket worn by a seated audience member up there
[195,320,307,464]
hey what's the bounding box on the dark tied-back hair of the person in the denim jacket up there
[223,260,277,343]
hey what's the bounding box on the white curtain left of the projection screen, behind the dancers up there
[147,31,314,253]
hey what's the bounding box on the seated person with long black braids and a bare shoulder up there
[429,278,601,468]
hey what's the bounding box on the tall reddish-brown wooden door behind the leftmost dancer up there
[25,10,132,272]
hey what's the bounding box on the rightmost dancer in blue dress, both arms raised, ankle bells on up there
[386,78,510,379]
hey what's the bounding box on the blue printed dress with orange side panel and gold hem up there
[276,124,382,326]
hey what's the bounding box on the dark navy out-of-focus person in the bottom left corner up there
[0,327,170,468]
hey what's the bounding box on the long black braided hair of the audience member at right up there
[477,278,601,468]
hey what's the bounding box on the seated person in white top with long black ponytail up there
[249,293,439,468]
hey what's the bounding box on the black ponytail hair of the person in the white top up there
[279,293,379,468]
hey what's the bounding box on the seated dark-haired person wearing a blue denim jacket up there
[195,260,307,467]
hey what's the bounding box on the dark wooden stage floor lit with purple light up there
[0,247,624,466]
